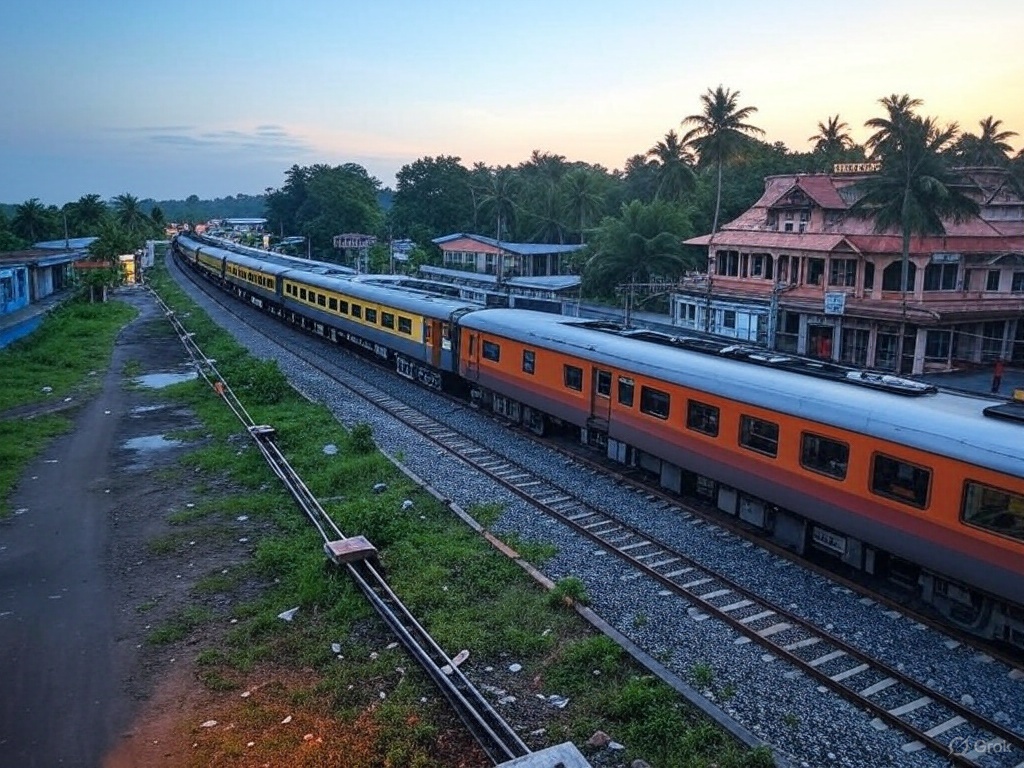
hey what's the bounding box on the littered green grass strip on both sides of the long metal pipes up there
[134,269,771,768]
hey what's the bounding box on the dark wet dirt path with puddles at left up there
[0,290,208,768]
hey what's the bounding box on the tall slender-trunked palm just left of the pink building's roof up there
[682,85,764,234]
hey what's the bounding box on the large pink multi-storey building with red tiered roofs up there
[672,164,1024,375]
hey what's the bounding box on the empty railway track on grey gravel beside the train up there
[169,256,1024,768]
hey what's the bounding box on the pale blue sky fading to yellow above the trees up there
[0,0,1024,205]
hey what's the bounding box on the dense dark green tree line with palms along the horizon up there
[0,91,1024,303]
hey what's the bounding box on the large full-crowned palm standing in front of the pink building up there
[851,95,979,370]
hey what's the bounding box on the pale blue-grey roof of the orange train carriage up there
[460,309,1024,477]
